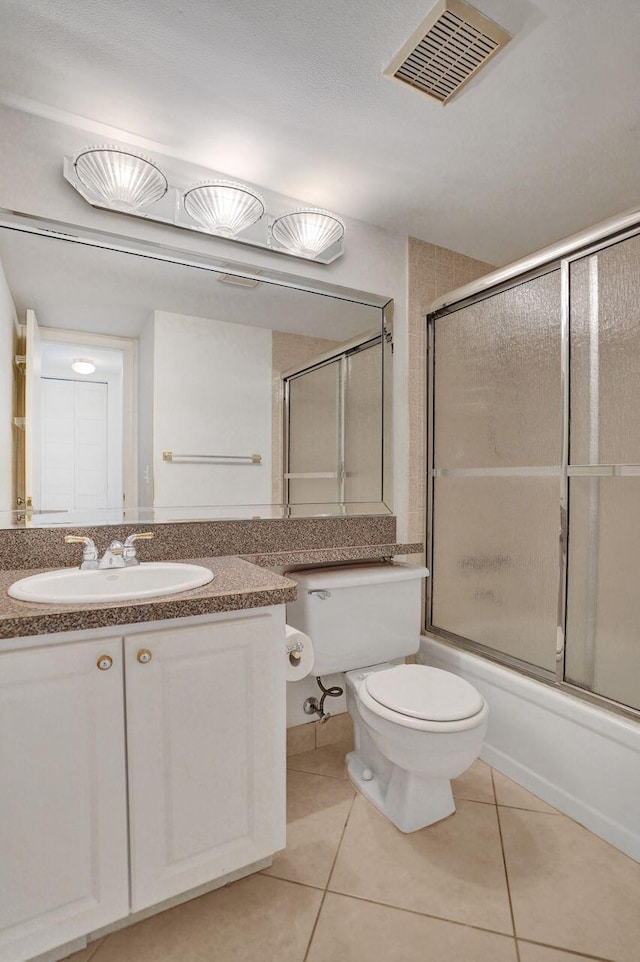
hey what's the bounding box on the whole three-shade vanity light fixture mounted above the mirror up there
[64,145,345,264]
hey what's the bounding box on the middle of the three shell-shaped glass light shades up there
[184,180,264,237]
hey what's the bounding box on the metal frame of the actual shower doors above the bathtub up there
[425,219,640,721]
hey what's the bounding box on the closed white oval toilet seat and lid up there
[357,665,487,732]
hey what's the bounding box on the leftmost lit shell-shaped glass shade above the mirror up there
[73,147,169,212]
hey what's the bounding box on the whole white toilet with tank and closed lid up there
[287,564,489,832]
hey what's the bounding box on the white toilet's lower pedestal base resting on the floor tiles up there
[346,750,456,834]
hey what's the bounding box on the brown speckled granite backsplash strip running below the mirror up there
[0,515,396,570]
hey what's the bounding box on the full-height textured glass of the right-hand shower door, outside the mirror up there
[564,236,640,709]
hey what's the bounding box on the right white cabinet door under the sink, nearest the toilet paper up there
[125,606,286,912]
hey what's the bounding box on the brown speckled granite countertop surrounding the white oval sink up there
[0,557,296,638]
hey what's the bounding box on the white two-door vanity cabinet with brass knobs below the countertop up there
[0,606,286,962]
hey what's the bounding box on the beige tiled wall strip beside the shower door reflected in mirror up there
[271,331,340,504]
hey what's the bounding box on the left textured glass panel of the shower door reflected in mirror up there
[289,361,340,504]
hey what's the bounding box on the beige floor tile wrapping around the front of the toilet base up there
[329,796,513,935]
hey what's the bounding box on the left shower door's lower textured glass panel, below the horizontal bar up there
[431,478,560,671]
